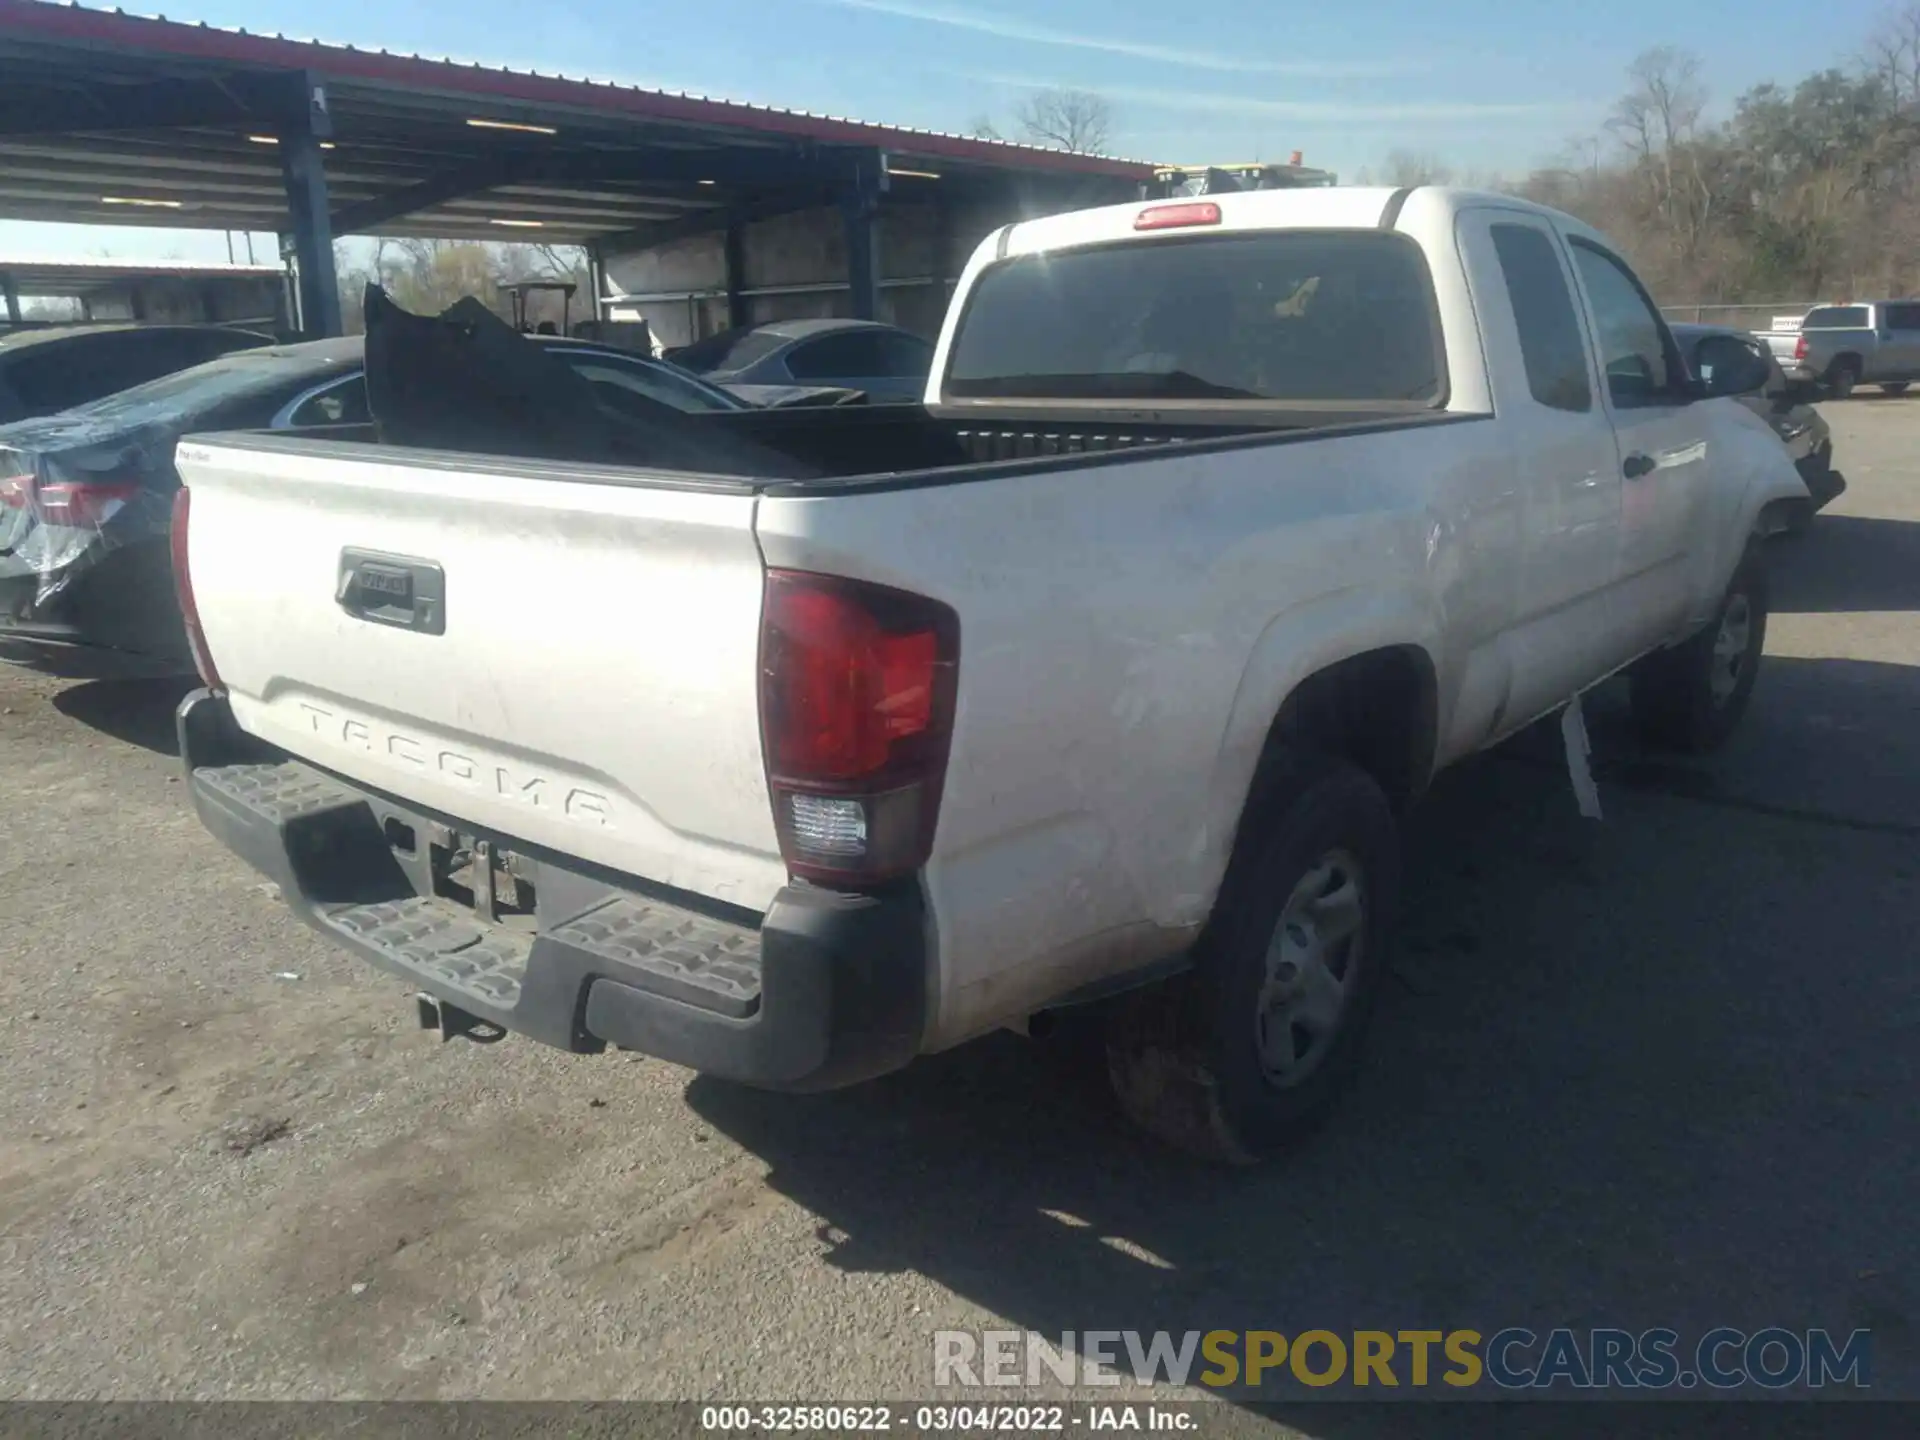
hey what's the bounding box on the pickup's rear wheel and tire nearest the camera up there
[1108,755,1400,1164]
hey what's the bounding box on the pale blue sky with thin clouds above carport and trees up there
[0,0,1889,263]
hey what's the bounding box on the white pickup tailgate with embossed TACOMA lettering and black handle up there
[177,438,787,910]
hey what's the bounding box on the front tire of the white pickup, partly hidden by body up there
[1632,549,1766,755]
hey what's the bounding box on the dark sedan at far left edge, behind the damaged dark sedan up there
[0,324,273,424]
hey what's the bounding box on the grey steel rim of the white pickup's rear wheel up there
[1254,851,1367,1089]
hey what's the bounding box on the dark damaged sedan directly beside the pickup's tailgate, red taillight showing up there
[0,336,751,676]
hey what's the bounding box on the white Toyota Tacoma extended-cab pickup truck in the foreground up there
[173,188,1807,1160]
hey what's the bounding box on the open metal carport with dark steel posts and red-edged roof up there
[0,0,1152,334]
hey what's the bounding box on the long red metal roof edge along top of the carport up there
[0,0,1154,179]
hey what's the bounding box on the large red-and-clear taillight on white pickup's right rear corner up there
[760,570,960,883]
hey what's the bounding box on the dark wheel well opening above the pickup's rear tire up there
[1242,645,1438,828]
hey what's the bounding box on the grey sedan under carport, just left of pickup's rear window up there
[668,321,933,401]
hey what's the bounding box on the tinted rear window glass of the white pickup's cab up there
[945,230,1446,405]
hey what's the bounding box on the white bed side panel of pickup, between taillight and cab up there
[758,422,1515,1044]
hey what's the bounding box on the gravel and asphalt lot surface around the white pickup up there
[0,396,1920,1428]
